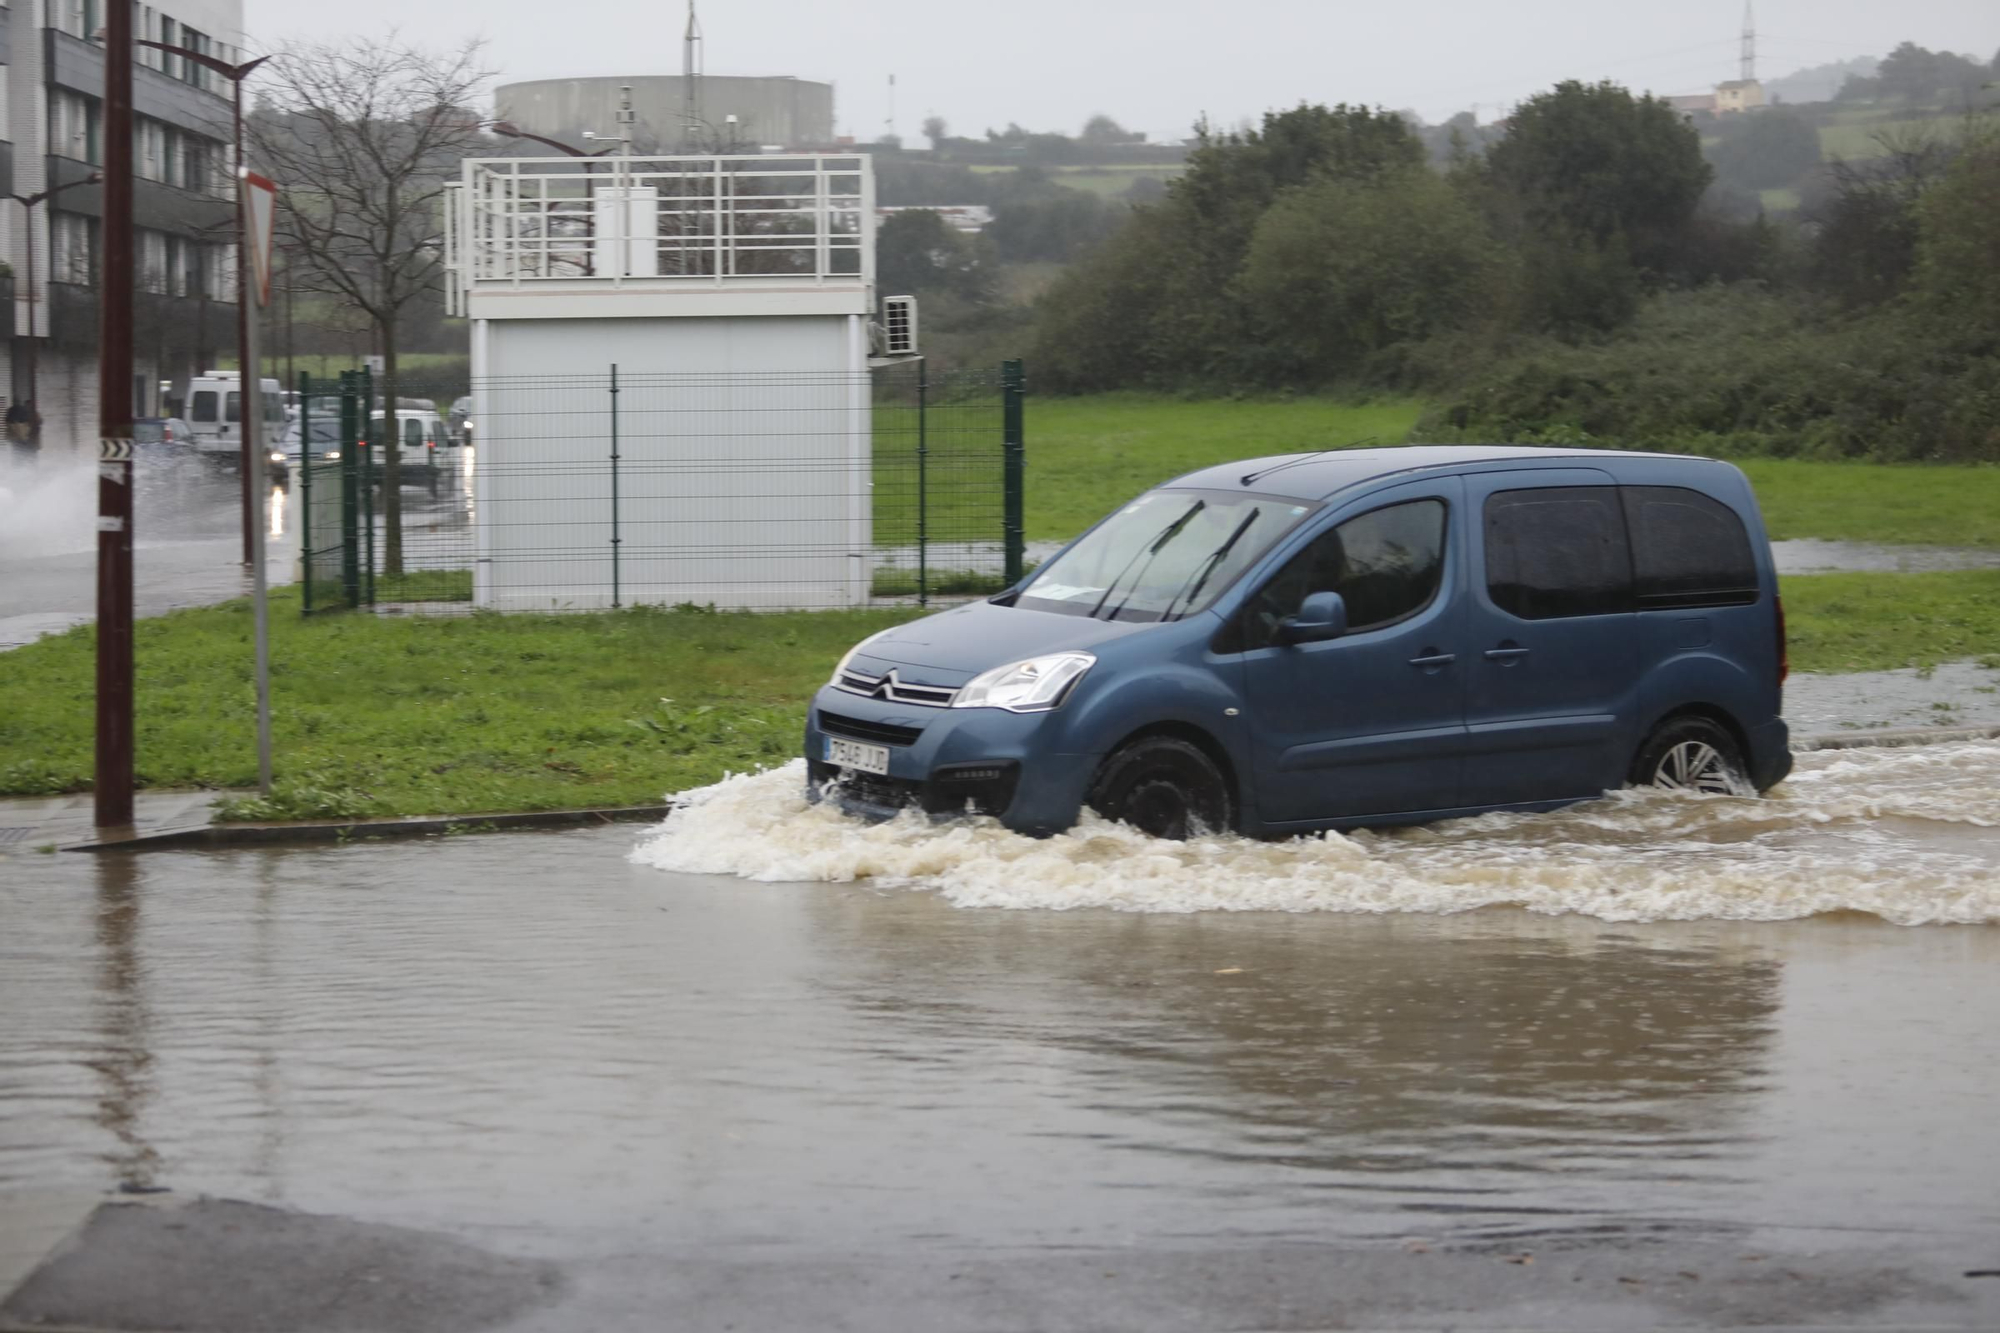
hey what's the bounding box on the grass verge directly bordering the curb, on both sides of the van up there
[0,570,2000,819]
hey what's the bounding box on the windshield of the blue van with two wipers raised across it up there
[1016,490,1314,620]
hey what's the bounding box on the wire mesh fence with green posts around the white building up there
[294,362,1026,612]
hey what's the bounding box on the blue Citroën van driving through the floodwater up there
[806,446,1792,839]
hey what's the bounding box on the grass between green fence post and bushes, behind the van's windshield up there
[1026,394,1422,540]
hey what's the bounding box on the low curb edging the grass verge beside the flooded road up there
[60,727,2000,853]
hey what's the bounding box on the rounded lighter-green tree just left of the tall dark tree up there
[1240,168,1502,382]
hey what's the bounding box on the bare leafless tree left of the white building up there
[248,34,490,574]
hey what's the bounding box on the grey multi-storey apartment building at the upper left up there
[0,0,244,452]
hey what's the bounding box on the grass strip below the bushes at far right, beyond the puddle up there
[1734,458,2000,548]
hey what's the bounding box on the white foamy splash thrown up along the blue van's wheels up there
[632,743,2000,925]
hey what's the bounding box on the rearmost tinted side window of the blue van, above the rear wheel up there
[1620,486,1756,610]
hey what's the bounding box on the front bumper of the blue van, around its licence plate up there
[806,685,1102,837]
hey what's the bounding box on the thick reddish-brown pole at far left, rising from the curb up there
[92,0,132,827]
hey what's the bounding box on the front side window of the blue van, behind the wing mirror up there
[1216,500,1444,652]
